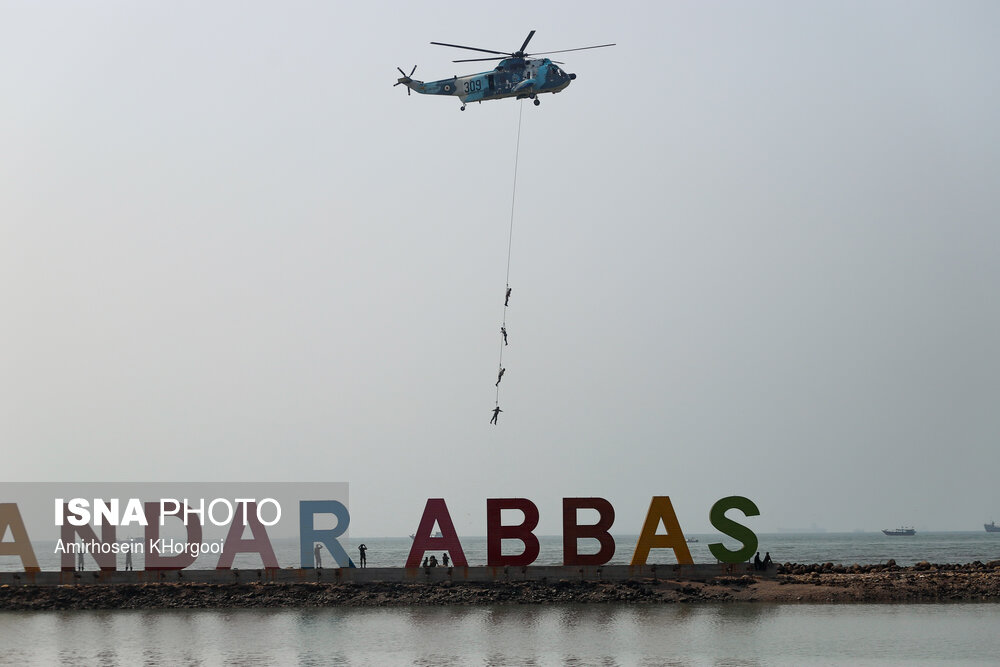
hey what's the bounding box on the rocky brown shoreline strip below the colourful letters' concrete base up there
[0,561,1000,611]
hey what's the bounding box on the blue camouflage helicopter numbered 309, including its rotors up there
[393,30,614,111]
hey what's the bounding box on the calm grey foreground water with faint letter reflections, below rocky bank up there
[0,604,1000,666]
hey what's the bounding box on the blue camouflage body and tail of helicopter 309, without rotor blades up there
[398,58,576,108]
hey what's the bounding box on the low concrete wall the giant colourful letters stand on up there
[0,563,776,586]
